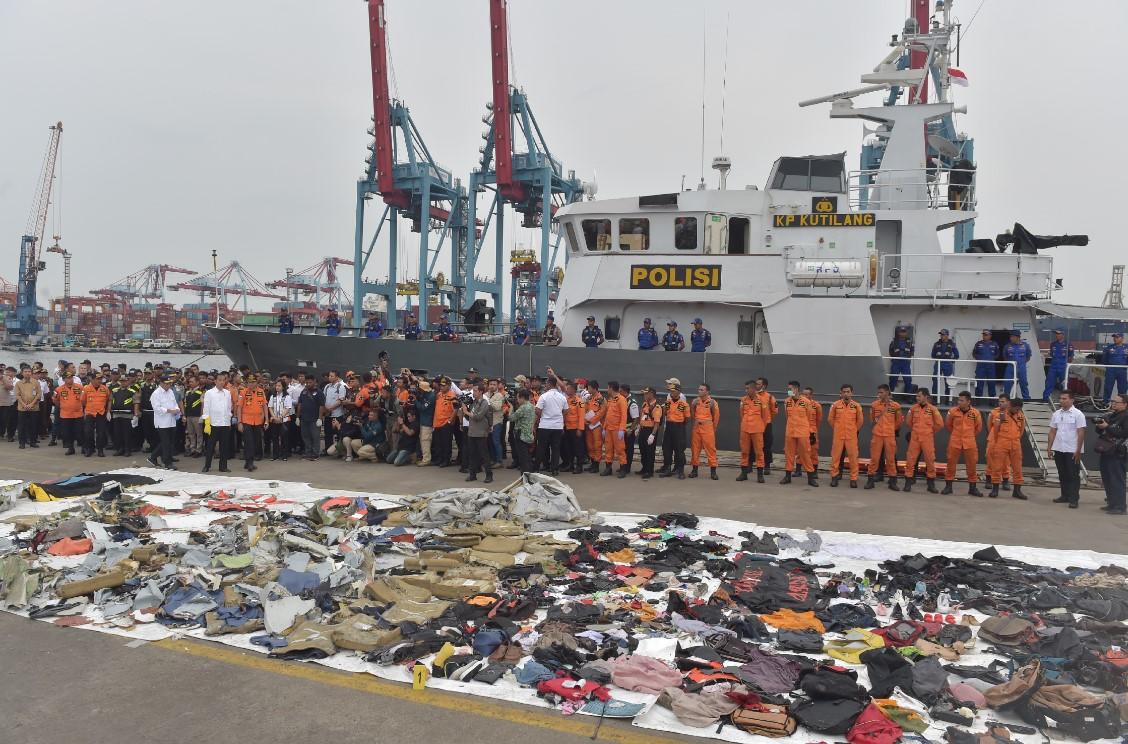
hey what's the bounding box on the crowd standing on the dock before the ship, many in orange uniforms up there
[0,353,1128,514]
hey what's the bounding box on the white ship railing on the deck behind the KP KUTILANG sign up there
[874,253,1054,299]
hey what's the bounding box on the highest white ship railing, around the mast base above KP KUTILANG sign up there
[846,163,977,207]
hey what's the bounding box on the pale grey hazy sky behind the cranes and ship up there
[0,0,1128,303]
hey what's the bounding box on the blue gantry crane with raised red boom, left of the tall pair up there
[353,0,468,326]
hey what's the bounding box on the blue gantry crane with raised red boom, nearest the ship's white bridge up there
[464,0,583,328]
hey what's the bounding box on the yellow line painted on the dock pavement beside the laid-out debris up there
[150,638,684,744]
